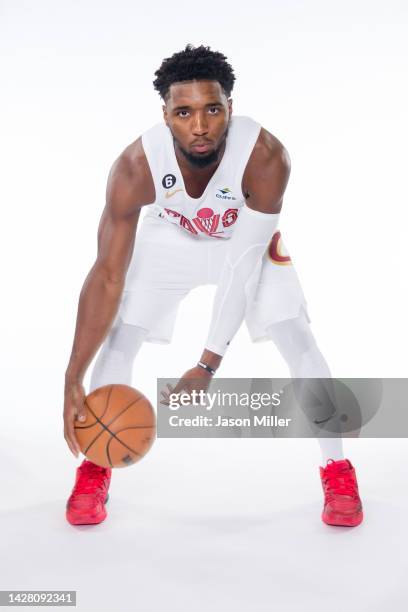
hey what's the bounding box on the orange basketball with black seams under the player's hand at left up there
[75,385,156,468]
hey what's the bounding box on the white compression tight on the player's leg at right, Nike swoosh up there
[267,310,344,466]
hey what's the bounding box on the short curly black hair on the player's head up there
[153,45,235,100]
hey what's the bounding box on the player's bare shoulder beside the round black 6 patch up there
[106,137,155,214]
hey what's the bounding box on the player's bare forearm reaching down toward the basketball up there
[65,268,124,382]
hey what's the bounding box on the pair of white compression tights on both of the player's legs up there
[89,313,344,465]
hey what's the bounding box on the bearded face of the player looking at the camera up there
[163,81,232,168]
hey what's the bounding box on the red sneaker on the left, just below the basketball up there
[66,459,112,525]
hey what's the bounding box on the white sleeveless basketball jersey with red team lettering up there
[142,116,261,238]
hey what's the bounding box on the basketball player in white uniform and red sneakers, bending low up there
[64,45,363,526]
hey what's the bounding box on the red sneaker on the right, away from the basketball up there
[320,459,363,527]
